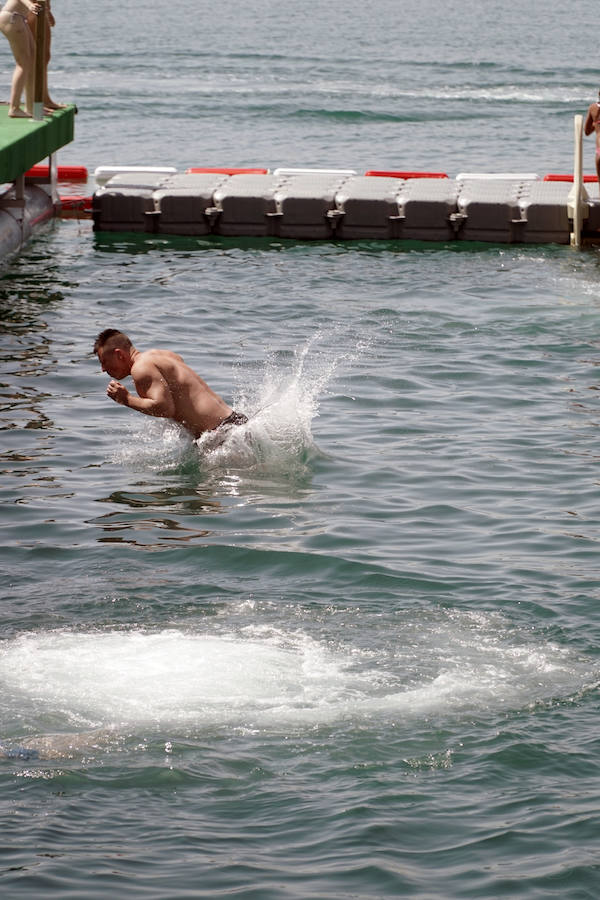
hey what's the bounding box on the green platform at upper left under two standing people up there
[0,106,75,184]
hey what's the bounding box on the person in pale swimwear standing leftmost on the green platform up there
[0,0,41,119]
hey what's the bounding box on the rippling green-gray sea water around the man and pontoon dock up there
[0,0,600,900]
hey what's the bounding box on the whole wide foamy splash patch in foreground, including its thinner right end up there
[0,611,598,754]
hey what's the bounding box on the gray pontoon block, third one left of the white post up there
[398,178,458,241]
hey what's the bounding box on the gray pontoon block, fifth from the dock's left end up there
[335,175,403,240]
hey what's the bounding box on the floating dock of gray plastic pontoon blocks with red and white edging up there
[93,168,600,244]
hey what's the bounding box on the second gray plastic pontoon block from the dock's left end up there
[154,172,229,234]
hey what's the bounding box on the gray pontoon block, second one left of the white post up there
[457,179,535,243]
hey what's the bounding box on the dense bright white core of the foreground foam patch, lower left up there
[0,630,356,727]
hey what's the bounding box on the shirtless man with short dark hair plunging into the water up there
[94,328,248,438]
